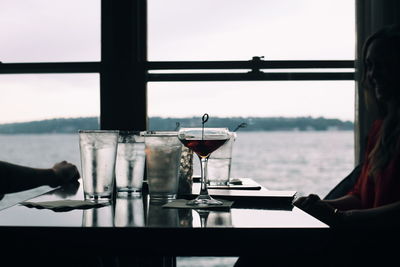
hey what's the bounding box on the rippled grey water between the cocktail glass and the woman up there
[194,131,354,197]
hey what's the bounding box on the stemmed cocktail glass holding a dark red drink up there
[178,128,230,206]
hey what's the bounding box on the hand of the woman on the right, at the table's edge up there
[293,194,340,226]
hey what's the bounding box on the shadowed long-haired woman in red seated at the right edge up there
[235,25,400,266]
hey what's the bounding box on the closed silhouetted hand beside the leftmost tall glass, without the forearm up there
[49,160,80,187]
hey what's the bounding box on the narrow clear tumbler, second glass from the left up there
[115,131,145,195]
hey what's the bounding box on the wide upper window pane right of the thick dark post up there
[148,0,355,61]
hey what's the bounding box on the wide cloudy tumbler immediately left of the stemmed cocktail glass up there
[143,131,182,200]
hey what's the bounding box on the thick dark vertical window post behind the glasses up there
[100,0,147,130]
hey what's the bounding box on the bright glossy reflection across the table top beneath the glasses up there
[0,179,327,228]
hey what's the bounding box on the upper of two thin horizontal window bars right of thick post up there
[147,60,355,70]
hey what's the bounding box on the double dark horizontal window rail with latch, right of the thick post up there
[147,57,355,82]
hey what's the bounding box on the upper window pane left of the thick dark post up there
[0,0,100,63]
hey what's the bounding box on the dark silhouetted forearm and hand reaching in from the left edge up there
[0,161,80,194]
